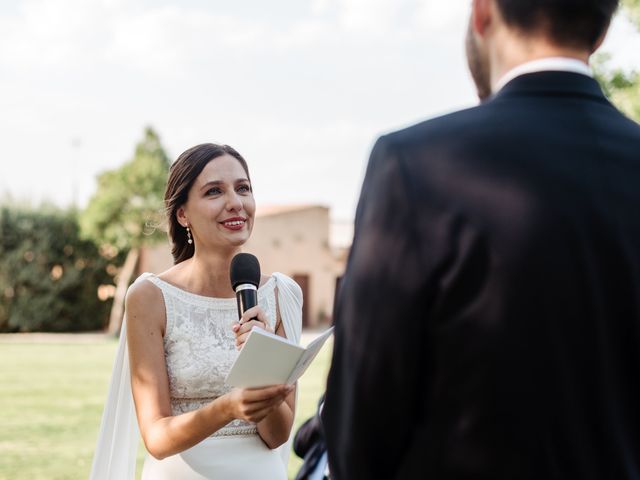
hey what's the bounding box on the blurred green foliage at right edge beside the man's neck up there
[594,0,640,122]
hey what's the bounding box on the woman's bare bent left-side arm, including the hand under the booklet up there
[126,282,291,459]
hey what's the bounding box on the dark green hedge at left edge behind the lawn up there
[0,206,113,332]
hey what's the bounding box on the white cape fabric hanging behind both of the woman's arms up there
[89,273,302,480]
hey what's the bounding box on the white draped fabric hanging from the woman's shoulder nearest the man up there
[273,273,303,468]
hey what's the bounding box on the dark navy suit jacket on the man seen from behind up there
[323,72,640,480]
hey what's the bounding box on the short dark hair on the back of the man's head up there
[496,0,619,48]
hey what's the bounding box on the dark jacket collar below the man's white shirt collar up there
[489,71,608,103]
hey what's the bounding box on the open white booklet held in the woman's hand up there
[226,327,333,388]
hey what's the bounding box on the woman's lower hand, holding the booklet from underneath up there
[225,385,294,423]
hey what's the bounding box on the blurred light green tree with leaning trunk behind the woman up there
[80,127,169,334]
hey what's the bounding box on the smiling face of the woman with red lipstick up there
[178,155,256,249]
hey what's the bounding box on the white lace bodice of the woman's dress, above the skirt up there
[141,274,276,436]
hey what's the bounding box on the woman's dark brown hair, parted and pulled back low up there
[164,143,251,264]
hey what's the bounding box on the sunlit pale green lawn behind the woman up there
[0,334,331,480]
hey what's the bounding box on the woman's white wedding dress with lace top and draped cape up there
[90,273,302,480]
